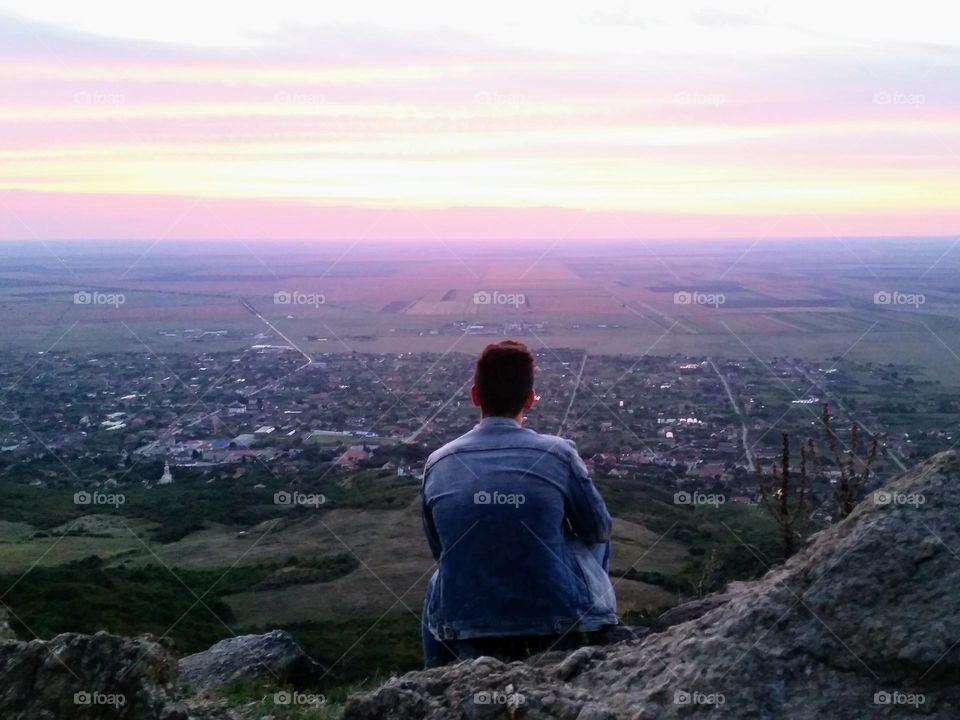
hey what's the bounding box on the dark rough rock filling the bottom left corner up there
[0,632,187,720]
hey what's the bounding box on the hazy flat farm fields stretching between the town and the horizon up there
[0,239,960,383]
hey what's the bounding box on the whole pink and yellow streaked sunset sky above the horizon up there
[0,0,960,241]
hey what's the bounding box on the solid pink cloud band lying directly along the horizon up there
[0,191,960,242]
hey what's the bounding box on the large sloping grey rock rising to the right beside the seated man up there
[344,451,960,720]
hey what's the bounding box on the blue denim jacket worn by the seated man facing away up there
[423,417,617,640]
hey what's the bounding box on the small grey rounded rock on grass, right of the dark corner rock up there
[179,630,325,692]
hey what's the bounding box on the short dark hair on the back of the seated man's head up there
[473,340,535,417]
